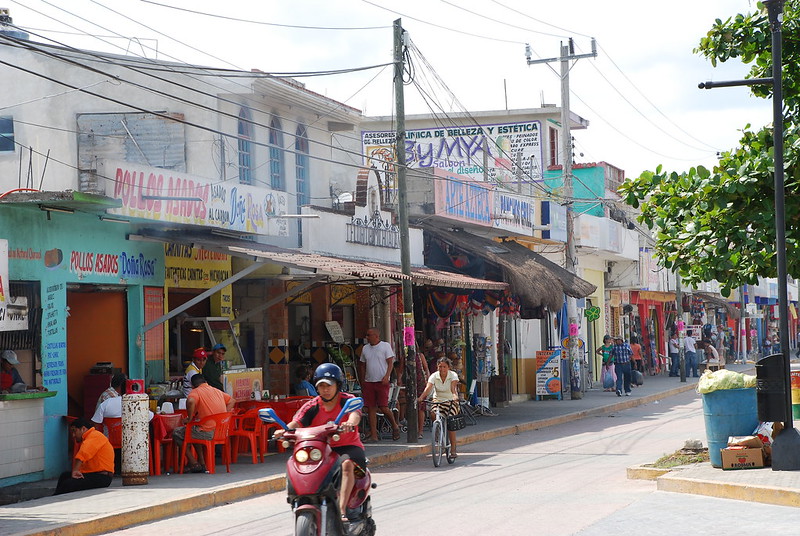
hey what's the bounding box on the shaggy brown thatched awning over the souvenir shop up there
[421,225,597,311]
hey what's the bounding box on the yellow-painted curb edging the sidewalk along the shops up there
[18,383,700,536]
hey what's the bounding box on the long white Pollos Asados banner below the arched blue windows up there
[97,160,289,236]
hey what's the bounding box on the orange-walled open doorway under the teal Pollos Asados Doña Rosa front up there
[67,285,128,417]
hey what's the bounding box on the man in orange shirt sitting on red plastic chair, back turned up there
[172,374,231,473]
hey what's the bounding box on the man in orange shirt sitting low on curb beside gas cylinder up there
[53,417,114,495]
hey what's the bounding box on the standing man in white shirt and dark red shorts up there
[359,328,400,443]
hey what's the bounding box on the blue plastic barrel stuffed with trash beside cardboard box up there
[703,388,758,467]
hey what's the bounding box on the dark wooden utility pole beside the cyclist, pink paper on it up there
[394,19,418,443]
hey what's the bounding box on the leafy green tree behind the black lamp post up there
[620,0,800,296]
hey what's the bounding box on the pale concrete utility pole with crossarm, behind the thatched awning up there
[525,37,597,400]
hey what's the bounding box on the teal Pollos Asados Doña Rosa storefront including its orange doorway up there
[0,205,164,485]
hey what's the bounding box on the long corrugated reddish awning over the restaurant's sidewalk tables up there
[131,230,508,290]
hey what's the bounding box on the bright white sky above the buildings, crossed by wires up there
[0,0,772,177]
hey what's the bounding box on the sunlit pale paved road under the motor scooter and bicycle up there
[101,393,800,536]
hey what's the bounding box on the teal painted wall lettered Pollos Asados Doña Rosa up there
[0,206,164,486]
